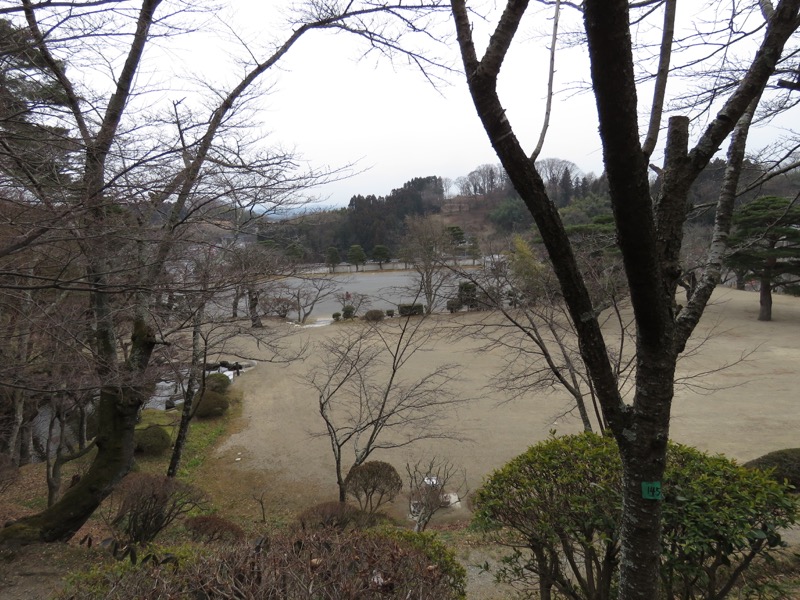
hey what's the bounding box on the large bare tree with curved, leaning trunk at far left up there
[0,0,450,541]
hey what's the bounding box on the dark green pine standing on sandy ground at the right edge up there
[727,196,800,321]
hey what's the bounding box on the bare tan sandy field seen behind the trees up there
[209,288,800,510]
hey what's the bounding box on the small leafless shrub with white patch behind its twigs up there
[406,456,467,533]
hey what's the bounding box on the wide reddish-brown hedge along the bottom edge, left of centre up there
[61,530,466,600]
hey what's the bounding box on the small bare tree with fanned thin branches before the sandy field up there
[305,317,466,502]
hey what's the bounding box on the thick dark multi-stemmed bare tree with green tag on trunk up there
[452,0,800,600]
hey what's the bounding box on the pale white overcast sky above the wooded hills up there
[159,0,791,205]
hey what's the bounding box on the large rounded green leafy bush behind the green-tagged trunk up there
[475,433,798,599]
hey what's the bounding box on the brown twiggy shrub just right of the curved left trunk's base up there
[109,473,204,545]
